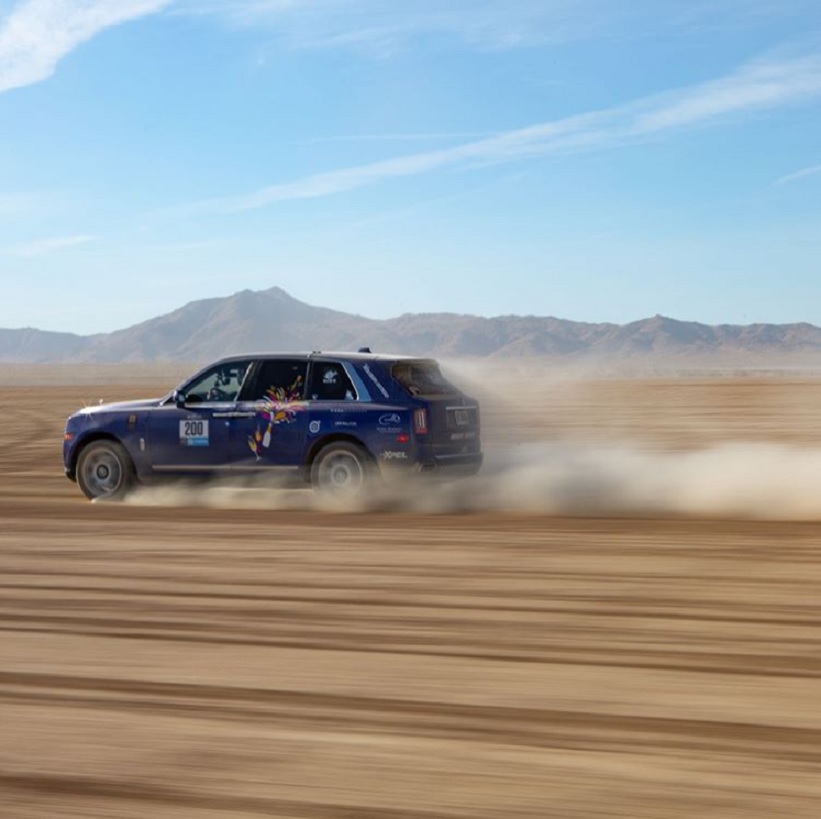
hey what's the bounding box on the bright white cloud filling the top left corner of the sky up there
[0,0,173,92]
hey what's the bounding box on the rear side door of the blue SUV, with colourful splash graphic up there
[231,357,308,473]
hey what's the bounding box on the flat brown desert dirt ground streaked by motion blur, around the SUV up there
[0,367,821,819]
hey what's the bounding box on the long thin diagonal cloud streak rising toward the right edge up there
[187,51,821,213]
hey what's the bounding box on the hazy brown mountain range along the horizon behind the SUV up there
[0,287,821,363]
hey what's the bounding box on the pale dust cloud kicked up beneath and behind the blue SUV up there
[118,443,821,520]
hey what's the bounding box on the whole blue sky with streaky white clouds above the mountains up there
[0,0,821,333]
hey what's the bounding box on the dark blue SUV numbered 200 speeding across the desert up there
[63,352,482,499]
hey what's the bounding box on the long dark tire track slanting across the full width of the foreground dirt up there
[0,673,821,764]
